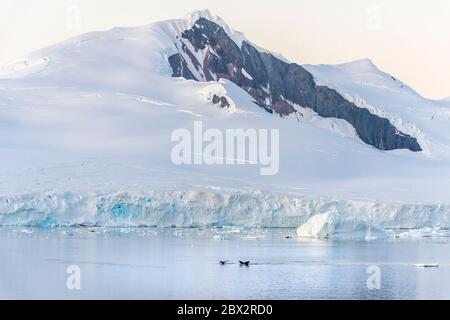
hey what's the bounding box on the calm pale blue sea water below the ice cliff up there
[0,228,450,299]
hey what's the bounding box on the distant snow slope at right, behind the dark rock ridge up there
[304,59,450,158]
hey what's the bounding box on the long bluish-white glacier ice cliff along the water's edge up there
[0,190,450,232]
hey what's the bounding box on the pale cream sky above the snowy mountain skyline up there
[0,0,450,99]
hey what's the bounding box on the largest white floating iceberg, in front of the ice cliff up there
[297,213,387,240]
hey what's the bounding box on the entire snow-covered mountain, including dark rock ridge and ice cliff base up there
[0,11,450,232]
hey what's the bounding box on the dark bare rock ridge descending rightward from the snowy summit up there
[169,18,422,151]
